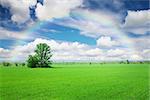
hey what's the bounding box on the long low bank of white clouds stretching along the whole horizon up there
[0,38,150,61]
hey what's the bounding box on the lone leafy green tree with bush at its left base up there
[27,43,52,68]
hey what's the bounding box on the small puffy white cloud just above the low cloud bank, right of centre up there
[97,36,119,47]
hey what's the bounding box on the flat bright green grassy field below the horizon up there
[0,64,150,100]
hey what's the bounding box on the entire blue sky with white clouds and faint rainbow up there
[0,0,150,62]
